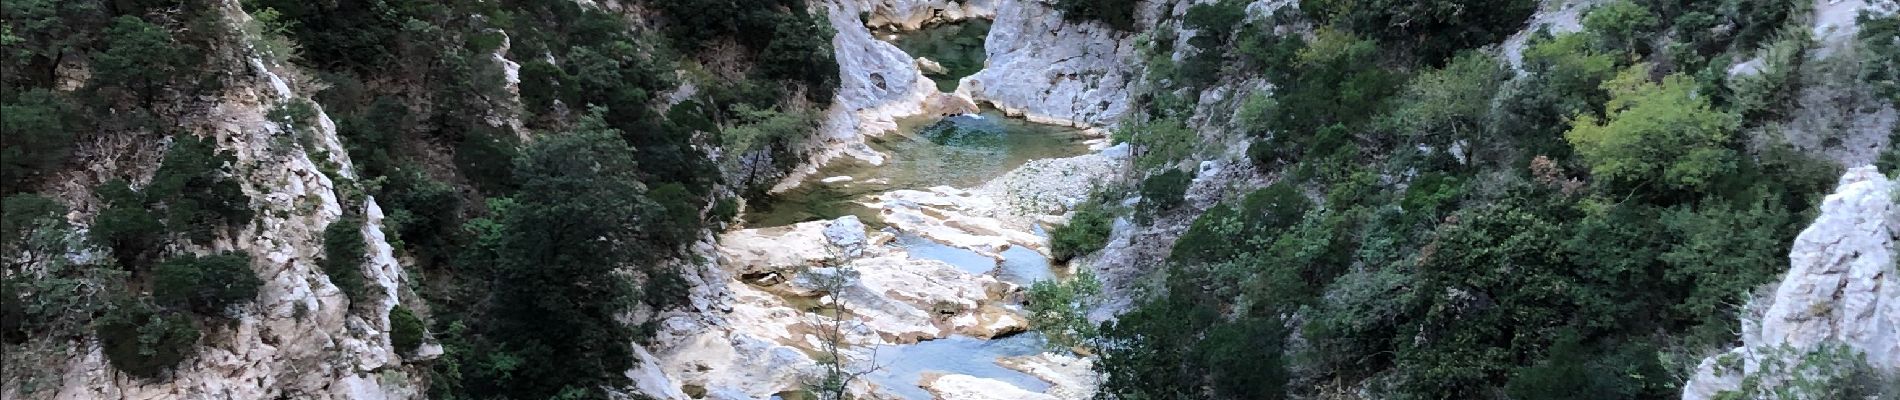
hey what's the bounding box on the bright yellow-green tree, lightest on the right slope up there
[1564,66,1739,190]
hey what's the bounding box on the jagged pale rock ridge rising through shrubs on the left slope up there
[26,2,424,398]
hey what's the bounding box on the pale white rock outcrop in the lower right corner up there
[1682,167,1900,400]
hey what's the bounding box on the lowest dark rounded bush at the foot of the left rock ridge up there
[95,301,200,379]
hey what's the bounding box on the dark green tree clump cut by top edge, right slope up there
[1300,0,1537,63]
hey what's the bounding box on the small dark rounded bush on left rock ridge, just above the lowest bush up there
[152,252,264,317]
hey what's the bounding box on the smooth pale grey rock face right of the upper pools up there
[958,0,1138,127]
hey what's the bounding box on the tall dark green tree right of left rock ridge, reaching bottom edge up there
[464,116,671,398]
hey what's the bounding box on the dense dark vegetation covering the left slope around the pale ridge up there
[0,0,838,398]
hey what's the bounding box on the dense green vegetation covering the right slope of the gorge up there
[1079,0,1892,398]
